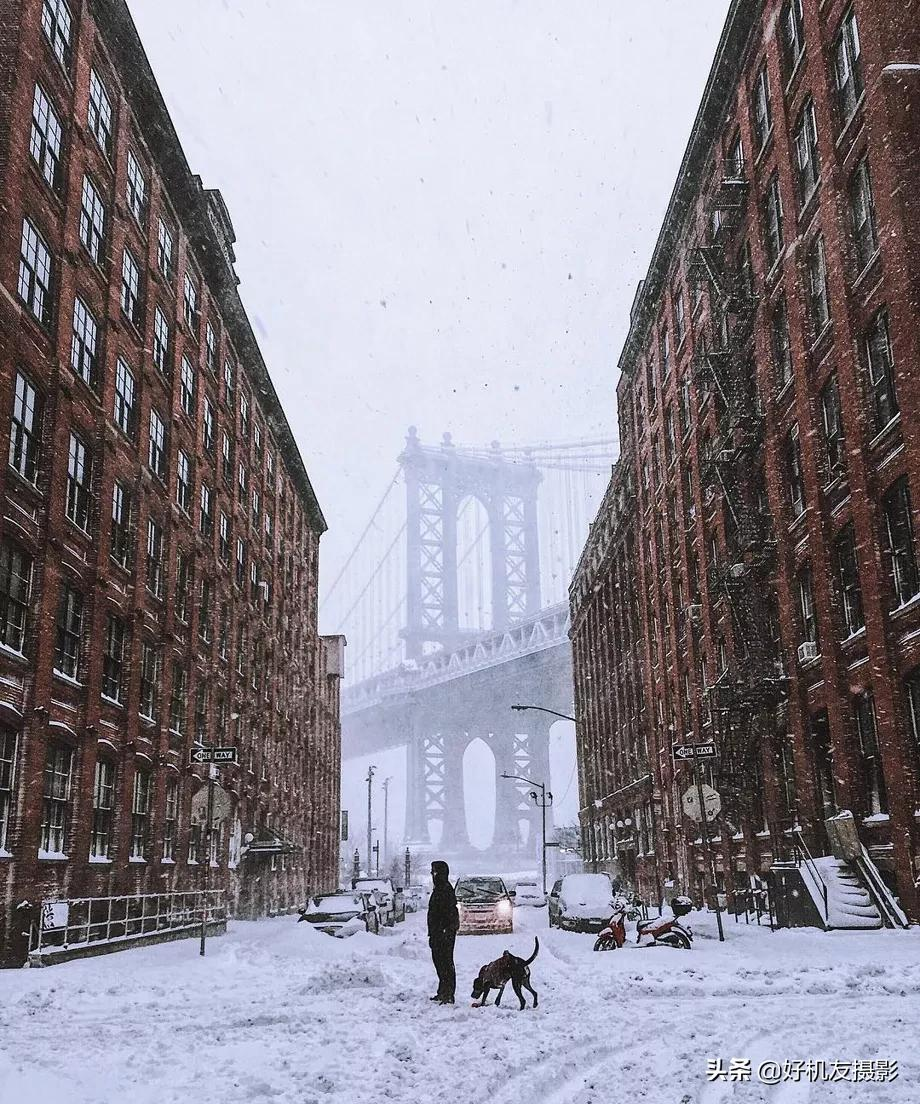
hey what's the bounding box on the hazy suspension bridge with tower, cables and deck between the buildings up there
[320,427,616,854]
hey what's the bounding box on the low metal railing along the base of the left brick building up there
[29,890,228,955]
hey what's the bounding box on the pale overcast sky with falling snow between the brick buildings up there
[129,0,728,838]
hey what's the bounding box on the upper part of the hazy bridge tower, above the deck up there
[399,426,542,659]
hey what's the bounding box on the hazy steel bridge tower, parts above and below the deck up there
[399,426,548,850]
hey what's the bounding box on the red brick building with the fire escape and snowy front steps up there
[571,0,920,916]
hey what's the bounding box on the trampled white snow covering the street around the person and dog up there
[0,907,920,1104]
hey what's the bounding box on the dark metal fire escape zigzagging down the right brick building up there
[689,161,786,831]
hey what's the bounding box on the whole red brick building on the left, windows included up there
[0,0,341,964]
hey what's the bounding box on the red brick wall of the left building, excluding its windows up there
[0,0,339,963]
